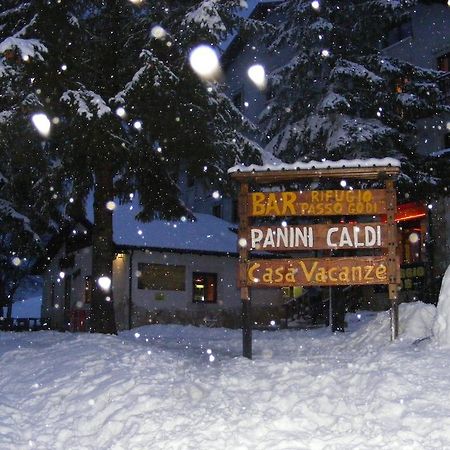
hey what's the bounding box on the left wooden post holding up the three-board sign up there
[238,182,252,359]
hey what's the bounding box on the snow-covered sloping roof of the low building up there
[113,203,237,253]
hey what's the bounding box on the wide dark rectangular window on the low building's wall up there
[138,263,186,291]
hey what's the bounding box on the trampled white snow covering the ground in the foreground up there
[0,303,450,450]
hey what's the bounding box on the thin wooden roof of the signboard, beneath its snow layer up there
[230,167,400,184]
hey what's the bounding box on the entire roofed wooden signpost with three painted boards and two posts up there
[229,158,400,358]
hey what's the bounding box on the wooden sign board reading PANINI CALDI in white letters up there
[240,223,387,252]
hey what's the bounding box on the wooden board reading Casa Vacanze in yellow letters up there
[246,256,389,287]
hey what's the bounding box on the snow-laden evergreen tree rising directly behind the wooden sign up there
[262,0,444,192]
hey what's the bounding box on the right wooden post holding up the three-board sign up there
[385,178,400,341]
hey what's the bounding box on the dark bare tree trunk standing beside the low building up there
[90,160,117,334]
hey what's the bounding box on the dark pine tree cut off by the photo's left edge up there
[0,1,60,318]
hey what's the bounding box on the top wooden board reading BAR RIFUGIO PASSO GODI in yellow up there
[248,189,386,217]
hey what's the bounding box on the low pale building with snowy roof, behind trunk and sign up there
[42,205,284,331]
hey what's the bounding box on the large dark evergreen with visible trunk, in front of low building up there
[0,0,257,333]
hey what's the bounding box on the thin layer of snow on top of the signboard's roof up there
[228,158,401,173]
